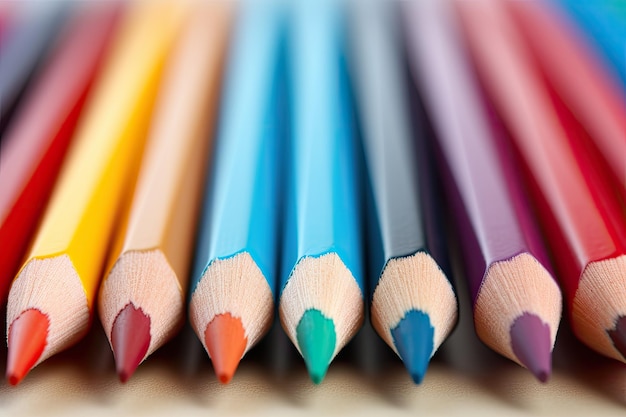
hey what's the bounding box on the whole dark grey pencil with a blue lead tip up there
[350,2,458,383]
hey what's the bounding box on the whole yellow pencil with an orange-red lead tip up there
[6,2,183,385]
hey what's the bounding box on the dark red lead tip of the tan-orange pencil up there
[111,303,151,383]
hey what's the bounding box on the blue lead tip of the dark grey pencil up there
[391,310,435,384]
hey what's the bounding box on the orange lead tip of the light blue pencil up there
[204,313,248,384]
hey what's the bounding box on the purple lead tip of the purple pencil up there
[510,313,552,382]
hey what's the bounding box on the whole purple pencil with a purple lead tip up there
[403,1,561,382]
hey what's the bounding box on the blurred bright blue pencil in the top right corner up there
[553,0,626,92]
